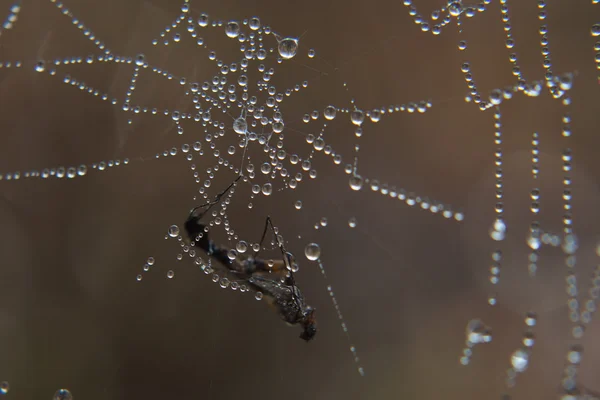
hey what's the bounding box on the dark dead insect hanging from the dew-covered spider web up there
[185,175,317,342]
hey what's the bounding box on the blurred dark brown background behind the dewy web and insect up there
[0,0,600,400]
